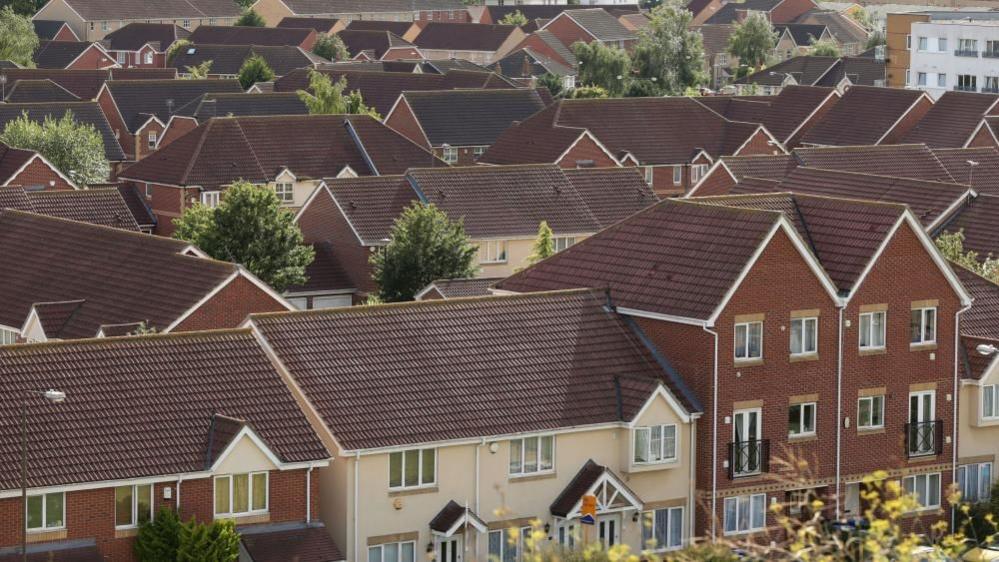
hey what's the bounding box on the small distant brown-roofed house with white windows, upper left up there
[101,23,191,68]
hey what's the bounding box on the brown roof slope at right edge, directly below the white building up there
[904,91,999,148]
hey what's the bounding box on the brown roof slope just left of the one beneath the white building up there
[801,86,926,146]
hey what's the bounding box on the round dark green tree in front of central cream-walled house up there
[371,203,478,302]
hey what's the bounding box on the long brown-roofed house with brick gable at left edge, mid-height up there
[0,209,289,343]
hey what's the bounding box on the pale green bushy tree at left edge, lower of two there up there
[0,110,111,186]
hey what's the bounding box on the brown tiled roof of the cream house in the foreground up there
[252,291,699,450]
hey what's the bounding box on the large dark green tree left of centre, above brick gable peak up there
[173,181,315,291]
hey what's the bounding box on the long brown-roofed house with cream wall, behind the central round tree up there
[287,164,656,302]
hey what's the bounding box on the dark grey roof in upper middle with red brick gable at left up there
[402,88,545,146]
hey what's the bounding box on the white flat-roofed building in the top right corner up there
[906,14,999,98]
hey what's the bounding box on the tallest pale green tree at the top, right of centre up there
[632,0,708,95]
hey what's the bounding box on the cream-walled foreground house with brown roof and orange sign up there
[248,290,706,562]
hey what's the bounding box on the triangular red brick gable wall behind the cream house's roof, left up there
[174,276,287,332]
